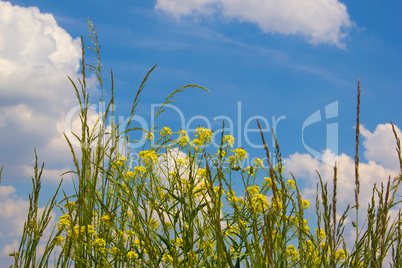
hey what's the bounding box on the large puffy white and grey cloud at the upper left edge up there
[0,1,81,182]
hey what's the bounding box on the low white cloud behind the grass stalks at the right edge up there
[285,124,402,258]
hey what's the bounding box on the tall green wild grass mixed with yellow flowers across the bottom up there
[0,22,402,268]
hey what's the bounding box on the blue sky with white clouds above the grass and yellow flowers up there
[0,0,402,264]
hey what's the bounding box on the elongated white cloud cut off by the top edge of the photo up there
[155,0,353,48]
